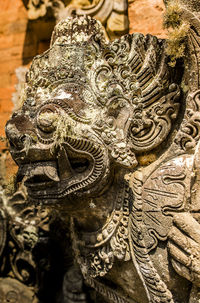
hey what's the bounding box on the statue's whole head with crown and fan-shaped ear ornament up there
[6,17,179,209]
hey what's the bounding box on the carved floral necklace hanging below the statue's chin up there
[71,185,132,278]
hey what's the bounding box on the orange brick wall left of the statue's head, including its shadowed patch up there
[0,0,55,185]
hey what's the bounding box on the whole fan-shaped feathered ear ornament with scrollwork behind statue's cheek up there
[104,34,180,153]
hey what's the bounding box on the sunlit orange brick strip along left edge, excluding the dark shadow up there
[0,0,28,184]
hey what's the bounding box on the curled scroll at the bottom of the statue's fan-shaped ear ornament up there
[128,84,180,153]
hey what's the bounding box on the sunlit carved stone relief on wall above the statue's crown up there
[24,0,129,39]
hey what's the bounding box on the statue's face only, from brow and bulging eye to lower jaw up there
[7,83,110,205]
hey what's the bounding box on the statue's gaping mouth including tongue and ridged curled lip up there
[18,141,104,200]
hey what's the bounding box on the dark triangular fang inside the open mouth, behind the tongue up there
[58,147,73,180]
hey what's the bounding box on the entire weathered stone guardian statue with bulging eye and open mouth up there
[3,0,200,303]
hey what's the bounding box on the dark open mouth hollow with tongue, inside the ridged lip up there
[18,153,93,199]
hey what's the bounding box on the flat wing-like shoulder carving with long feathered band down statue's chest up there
[129,155,193,303]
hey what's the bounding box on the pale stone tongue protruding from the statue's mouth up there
[17,161,60,182]
